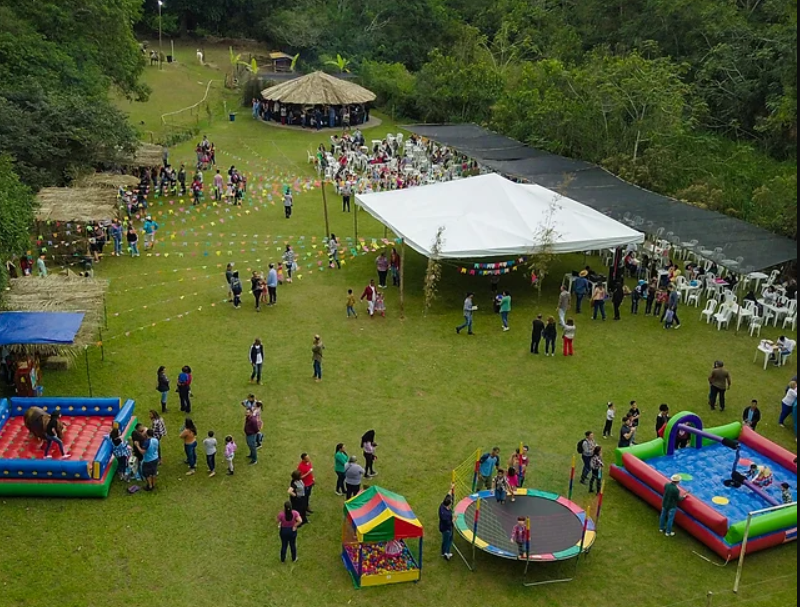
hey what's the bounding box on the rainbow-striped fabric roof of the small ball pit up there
[344,487,422,542]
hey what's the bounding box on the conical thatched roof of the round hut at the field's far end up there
[261,72,375,105]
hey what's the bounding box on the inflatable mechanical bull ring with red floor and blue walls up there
[0,398,136,497]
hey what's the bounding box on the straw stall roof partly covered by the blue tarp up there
[3,271,108,358]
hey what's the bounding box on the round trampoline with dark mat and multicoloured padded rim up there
[455,489,596,562]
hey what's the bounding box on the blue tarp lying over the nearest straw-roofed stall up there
[0,312,92,397]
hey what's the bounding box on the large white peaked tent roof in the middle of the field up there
[356,174,644,259]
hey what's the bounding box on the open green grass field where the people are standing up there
[0,50,797,607]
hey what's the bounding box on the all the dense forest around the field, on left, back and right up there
[0,0,797,284]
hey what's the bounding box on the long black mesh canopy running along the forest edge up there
[404,124,797,272]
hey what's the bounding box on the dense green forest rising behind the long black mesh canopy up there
[146,0,797,238]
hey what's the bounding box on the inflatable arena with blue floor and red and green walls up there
[610,412,797,561]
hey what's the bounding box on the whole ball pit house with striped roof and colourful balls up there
[342,487,423,588]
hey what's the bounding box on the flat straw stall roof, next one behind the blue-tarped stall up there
[36,188,118,222]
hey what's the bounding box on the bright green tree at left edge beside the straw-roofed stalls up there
[0,154,34,293]
